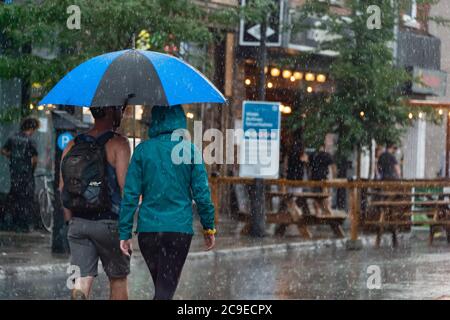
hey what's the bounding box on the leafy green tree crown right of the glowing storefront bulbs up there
[291,0,428,158]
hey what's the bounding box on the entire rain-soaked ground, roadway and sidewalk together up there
[4,212,450,300]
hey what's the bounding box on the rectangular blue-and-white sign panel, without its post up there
[239,101,281,179]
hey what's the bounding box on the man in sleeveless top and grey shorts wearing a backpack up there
[60,107,130,299]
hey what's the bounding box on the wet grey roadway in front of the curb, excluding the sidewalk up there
[0,231,450,299]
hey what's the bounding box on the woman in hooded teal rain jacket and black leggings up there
[119,106,215,299]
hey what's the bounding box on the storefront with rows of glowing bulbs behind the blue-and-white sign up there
[232,26,334,176]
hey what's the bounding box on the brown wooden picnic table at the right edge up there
[365,192,450,247]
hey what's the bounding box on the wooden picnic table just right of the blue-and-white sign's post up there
[240,191,347,239]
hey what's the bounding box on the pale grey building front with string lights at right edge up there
[396,24,449,179]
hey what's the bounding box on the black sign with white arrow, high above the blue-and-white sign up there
[239,0,284,47]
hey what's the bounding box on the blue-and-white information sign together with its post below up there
[239,101,281,237]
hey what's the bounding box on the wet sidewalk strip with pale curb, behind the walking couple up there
[0,214,356,279]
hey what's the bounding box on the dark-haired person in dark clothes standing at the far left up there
[1,118,39,232]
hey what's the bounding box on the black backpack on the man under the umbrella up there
[61,132,115,214]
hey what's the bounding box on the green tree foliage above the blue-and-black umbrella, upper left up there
[0,0,219,115]
